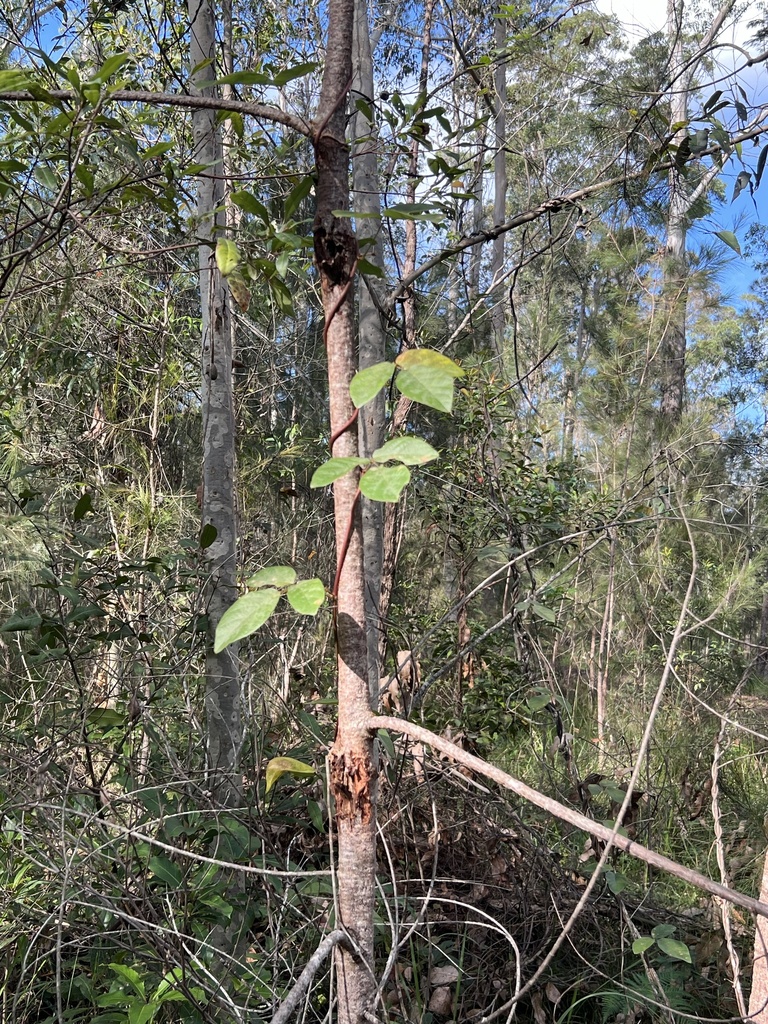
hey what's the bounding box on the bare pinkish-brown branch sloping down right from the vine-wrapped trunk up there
[368,715,768,918]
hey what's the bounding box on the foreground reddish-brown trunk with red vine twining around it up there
[313,0,376,1024]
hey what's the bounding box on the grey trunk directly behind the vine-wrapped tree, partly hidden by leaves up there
[351,0,386,707]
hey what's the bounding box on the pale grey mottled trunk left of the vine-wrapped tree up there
[188,0,243,806]
